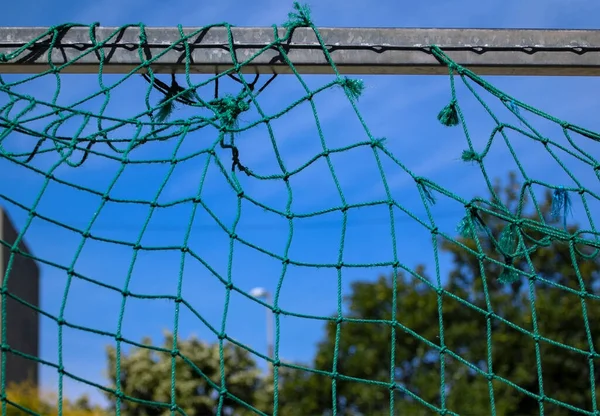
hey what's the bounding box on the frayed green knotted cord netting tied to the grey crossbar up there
[0,4,600,415]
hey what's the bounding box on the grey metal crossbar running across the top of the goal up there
[0,27,600,76]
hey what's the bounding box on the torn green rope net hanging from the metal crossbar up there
[0,5,600,415]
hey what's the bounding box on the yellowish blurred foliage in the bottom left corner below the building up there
[6,382,108,416]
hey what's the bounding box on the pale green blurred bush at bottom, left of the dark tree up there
[107,333,262,416]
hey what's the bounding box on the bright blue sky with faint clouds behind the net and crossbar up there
[0,0,600,408]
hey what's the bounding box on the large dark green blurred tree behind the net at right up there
[270,174,600,415]
